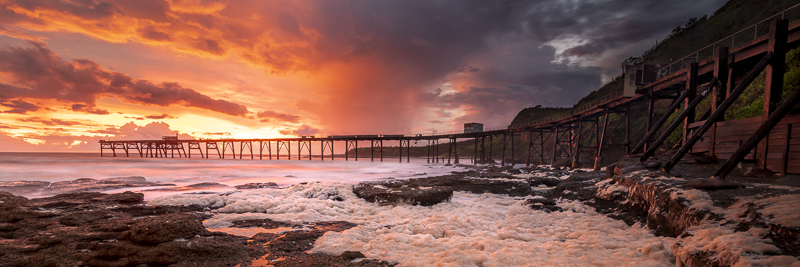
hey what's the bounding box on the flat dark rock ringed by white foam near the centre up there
[353,184,453,206]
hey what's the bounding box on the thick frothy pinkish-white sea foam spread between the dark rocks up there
[149,183,674,266]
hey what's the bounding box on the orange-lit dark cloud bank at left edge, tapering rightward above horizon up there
[0,43,247,116]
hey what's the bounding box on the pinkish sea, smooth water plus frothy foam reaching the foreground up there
[0,153,675,266]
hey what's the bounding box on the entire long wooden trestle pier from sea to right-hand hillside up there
[100,15,800,177]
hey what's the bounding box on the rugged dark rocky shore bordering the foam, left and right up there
[0,158,800,266]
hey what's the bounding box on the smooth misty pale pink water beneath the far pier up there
[0,153,463,199]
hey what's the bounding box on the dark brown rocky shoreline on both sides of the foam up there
[0,160,800,266]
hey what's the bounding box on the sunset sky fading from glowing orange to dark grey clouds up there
[0,0,725,152]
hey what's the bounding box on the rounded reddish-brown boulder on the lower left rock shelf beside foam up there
[120,213,210,244]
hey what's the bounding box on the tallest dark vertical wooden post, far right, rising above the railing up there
[756,20,789,168]
